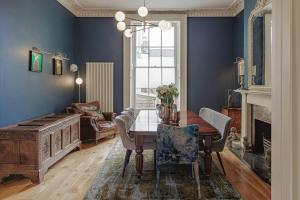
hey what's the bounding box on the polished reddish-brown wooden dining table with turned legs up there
[129,110,220,178]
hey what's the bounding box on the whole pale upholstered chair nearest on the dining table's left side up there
[115,115,156,177]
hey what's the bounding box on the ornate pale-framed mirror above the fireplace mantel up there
[248,0,272,91]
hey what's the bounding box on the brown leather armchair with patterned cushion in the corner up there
[66,101,118,144]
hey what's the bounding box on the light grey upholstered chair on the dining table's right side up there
[199,108,231,176]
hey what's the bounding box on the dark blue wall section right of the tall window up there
[188,18,234,112]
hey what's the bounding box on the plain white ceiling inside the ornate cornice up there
[72,0,236,11]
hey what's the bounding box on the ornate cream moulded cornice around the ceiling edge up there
[57,0,244,17]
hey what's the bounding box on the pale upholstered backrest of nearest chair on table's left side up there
[115,115,135,149]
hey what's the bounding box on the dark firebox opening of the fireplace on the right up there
[253,119,271,154]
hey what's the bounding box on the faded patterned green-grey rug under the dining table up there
[84,140,241,200]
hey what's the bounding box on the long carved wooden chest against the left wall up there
[0,114,81,183]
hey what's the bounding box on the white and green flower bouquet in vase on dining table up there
[156,83,179,124]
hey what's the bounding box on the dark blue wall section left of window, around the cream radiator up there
[75,18,123,113]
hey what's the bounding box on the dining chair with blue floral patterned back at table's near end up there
[156,124,201,199]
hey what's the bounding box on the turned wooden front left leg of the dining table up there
[135,135,144,178]
